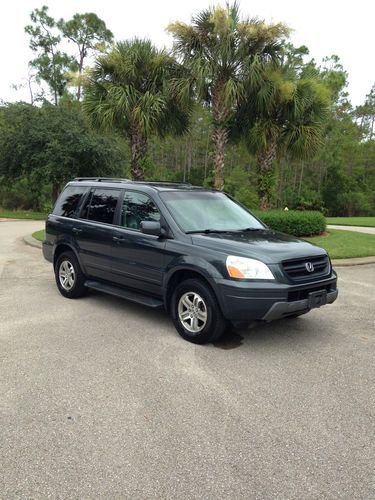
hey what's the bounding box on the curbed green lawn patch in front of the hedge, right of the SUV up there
[304,229,375,259]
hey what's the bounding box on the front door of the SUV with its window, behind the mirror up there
[112,190,166,295]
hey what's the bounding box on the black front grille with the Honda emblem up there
[282,255,330,281]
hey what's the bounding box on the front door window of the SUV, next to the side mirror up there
[121,191,160,230]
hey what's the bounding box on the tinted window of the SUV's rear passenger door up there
[85,188,120,224]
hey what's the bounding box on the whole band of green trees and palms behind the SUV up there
[0,3,375,215]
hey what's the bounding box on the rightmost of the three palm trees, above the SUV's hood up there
[237,62,330,210]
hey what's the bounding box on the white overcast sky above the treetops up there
[0,0,375,105]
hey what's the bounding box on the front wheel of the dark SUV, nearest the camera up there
[171,279,227,344]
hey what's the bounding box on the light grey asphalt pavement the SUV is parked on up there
[0,221,375,500]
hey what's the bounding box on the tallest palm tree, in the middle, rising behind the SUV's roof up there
[167,3,288,190]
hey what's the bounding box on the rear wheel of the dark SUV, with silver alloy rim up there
[55,252,87,299]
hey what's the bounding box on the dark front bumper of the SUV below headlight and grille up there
[216,272,338,322]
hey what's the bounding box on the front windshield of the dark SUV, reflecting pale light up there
[160,191,264,233]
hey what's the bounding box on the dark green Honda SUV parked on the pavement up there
[43,178,337,343]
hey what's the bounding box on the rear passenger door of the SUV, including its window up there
[73,187,121,280]
